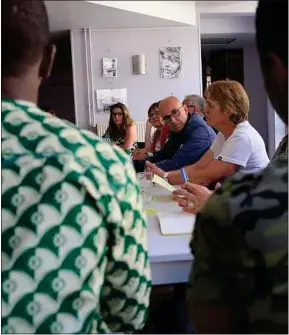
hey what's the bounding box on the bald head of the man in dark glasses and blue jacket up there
[159,96,188,132]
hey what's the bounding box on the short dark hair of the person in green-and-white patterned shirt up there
[1,0,49,77]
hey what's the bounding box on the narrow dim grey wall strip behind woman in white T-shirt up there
[244,45,270,149]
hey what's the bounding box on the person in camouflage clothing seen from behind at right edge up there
[187,0,288,334]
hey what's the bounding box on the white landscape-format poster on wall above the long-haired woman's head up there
[96,88,127,112]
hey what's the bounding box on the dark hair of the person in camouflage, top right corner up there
[256,0,288,67]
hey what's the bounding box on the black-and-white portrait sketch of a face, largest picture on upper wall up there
[159,47,182,79]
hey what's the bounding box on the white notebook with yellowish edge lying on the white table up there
[157,212,196,235]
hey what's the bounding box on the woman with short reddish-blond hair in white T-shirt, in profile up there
[147,80,269,187]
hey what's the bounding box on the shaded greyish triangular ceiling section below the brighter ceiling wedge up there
[45,1,189,31]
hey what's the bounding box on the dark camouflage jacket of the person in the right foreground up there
[188,159,288,334]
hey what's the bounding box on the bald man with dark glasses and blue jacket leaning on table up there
[147,96,215,171]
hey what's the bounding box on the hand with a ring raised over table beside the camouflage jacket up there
[173,183,213,214]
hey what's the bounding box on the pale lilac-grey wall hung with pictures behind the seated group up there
[71,27,201,128]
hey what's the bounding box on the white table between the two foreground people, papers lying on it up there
[145,185,193,285]
